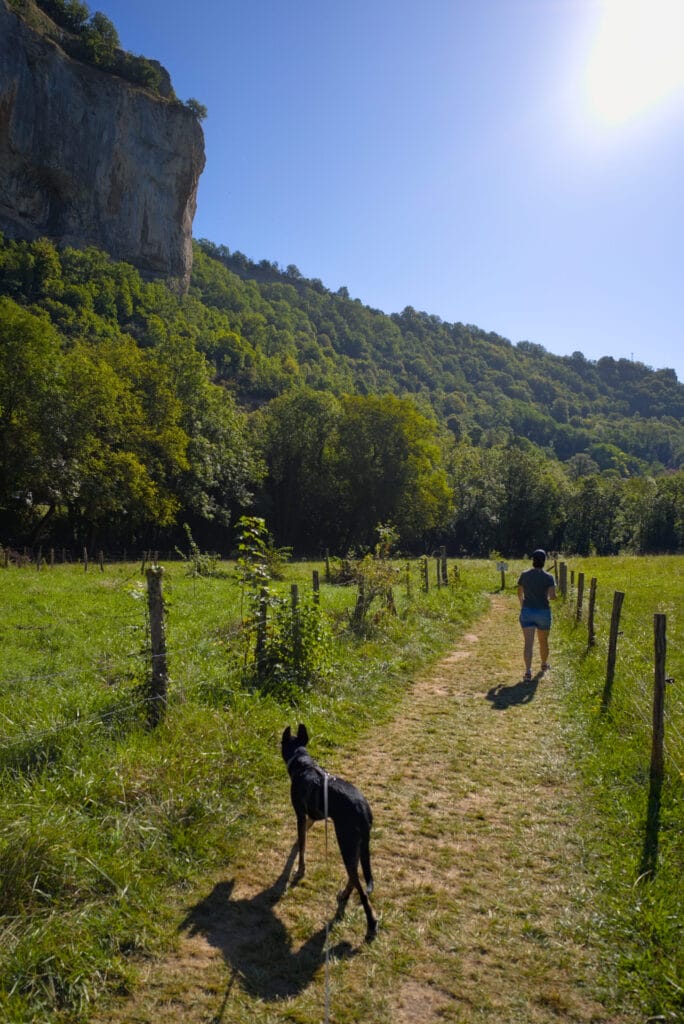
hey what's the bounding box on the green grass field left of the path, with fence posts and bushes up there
[0,563,496,1022]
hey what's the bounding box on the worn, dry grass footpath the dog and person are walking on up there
[94,595,634,1024]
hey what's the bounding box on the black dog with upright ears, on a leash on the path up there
[281,724,378,939]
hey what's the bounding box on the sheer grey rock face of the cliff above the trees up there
[0,0,205,286]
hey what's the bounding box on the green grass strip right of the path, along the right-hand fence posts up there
[556,557,684,1020]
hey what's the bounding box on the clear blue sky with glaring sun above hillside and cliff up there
[98,0,684,380]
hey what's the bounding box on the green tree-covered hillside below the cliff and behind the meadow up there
[0,232,684,555]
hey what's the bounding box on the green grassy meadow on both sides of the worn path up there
[0,557,684,1024]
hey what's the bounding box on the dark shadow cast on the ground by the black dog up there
[179,844,357,1003]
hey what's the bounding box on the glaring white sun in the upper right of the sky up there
[586,0,684,125]
